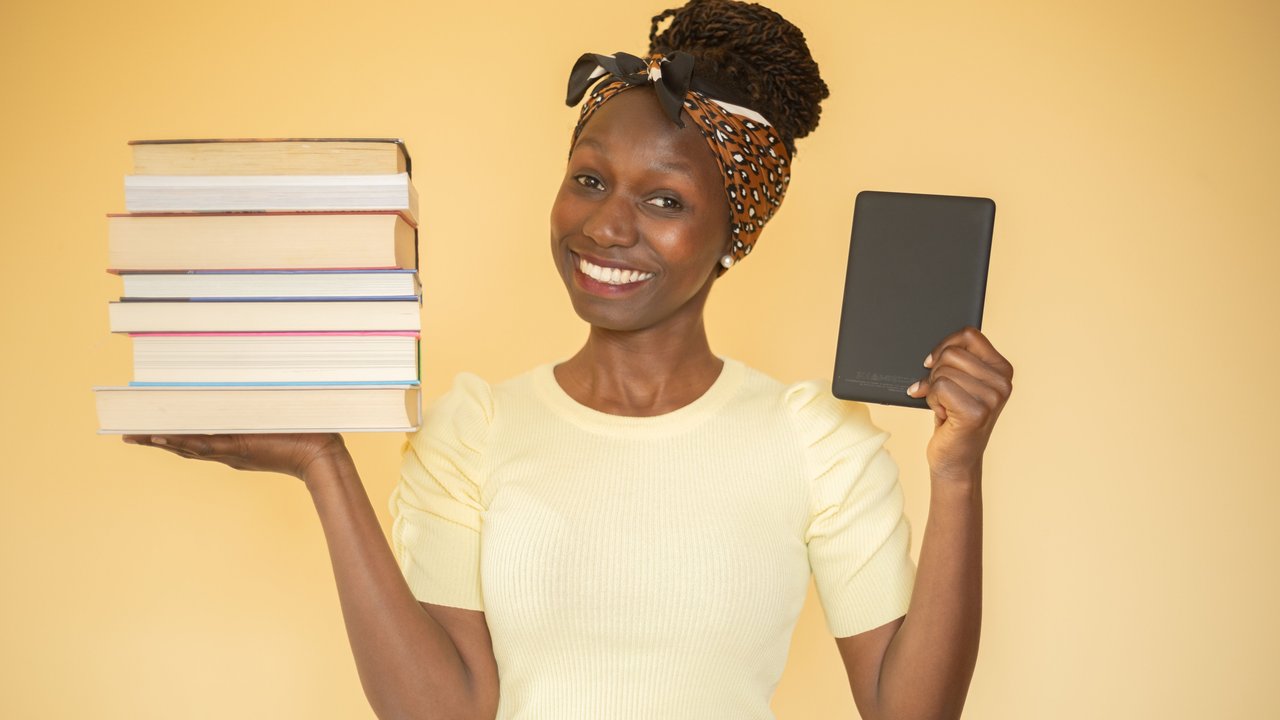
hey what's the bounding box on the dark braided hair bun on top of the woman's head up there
[649,0,831,155]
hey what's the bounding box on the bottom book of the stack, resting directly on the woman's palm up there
[93,386,422,434]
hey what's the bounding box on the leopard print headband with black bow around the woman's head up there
[566,53,791,273]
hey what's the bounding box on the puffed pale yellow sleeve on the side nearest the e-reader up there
[786,382,915,638]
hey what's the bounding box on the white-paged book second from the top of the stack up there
[124,173,417,223]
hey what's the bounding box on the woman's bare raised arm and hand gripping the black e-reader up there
[836,328,1014,720]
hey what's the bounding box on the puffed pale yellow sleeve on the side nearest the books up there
[390,373,493,610]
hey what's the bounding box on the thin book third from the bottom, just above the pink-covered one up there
[108,299,421,333]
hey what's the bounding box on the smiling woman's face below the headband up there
[552,88,730,331]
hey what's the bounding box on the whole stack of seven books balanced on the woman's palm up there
[93,138,422,434]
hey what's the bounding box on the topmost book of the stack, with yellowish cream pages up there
[129,137,411,176]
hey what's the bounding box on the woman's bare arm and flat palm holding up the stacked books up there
[125,434,498,720]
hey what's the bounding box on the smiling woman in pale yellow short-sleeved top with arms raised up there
[125,0,1012,719]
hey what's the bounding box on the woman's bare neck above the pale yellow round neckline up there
[556,316,724,418]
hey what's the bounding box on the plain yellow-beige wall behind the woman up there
[0,0,1280,720]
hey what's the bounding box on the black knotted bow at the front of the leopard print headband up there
[564,51,694,127]
